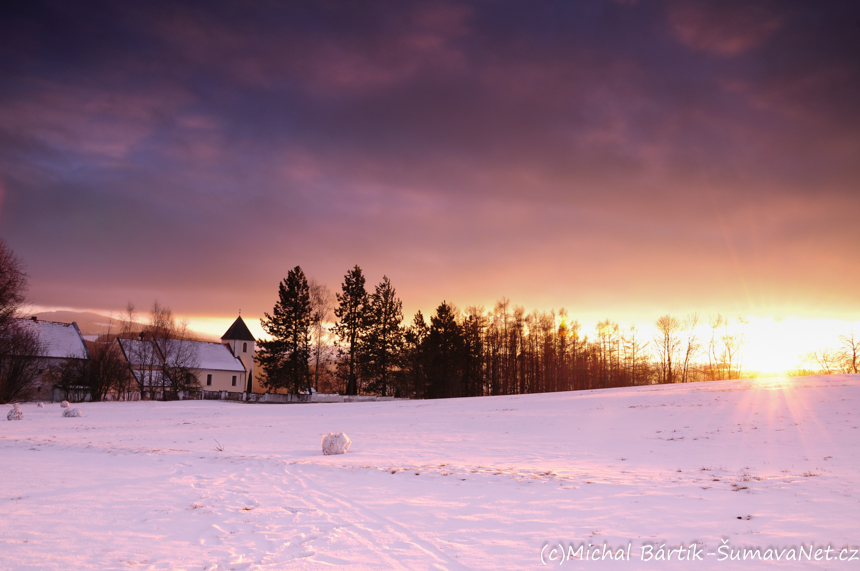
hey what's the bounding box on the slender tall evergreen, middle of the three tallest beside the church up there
[334,265,368,395]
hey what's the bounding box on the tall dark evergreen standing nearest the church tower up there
[257,266,311,392]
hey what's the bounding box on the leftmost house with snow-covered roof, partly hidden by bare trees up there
[17,316,90,400]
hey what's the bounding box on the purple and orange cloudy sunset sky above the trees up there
[0,0,860,356]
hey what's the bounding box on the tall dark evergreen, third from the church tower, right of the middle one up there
[363,276,403,396]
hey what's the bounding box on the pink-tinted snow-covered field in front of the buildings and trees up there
[0,376,860,570]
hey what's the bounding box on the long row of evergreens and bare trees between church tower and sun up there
[257,265,820,398]
